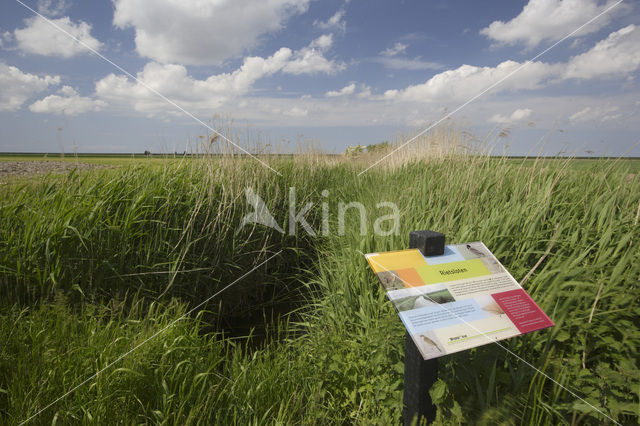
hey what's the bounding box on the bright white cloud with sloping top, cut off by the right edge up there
[564,25,640,79]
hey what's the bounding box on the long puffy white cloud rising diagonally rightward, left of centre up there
[96,36,338,114]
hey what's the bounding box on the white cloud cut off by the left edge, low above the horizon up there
[0,63,60,111]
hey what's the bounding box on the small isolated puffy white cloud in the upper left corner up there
[13,16,102,58]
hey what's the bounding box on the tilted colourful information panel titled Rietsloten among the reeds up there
[365,242,554,359]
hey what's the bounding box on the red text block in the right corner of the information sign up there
[491,289,554,334]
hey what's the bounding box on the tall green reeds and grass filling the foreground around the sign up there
[0,151,640,425]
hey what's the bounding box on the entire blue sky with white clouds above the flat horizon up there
[0,0,640,156]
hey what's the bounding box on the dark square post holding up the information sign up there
[402,231,445,426]
